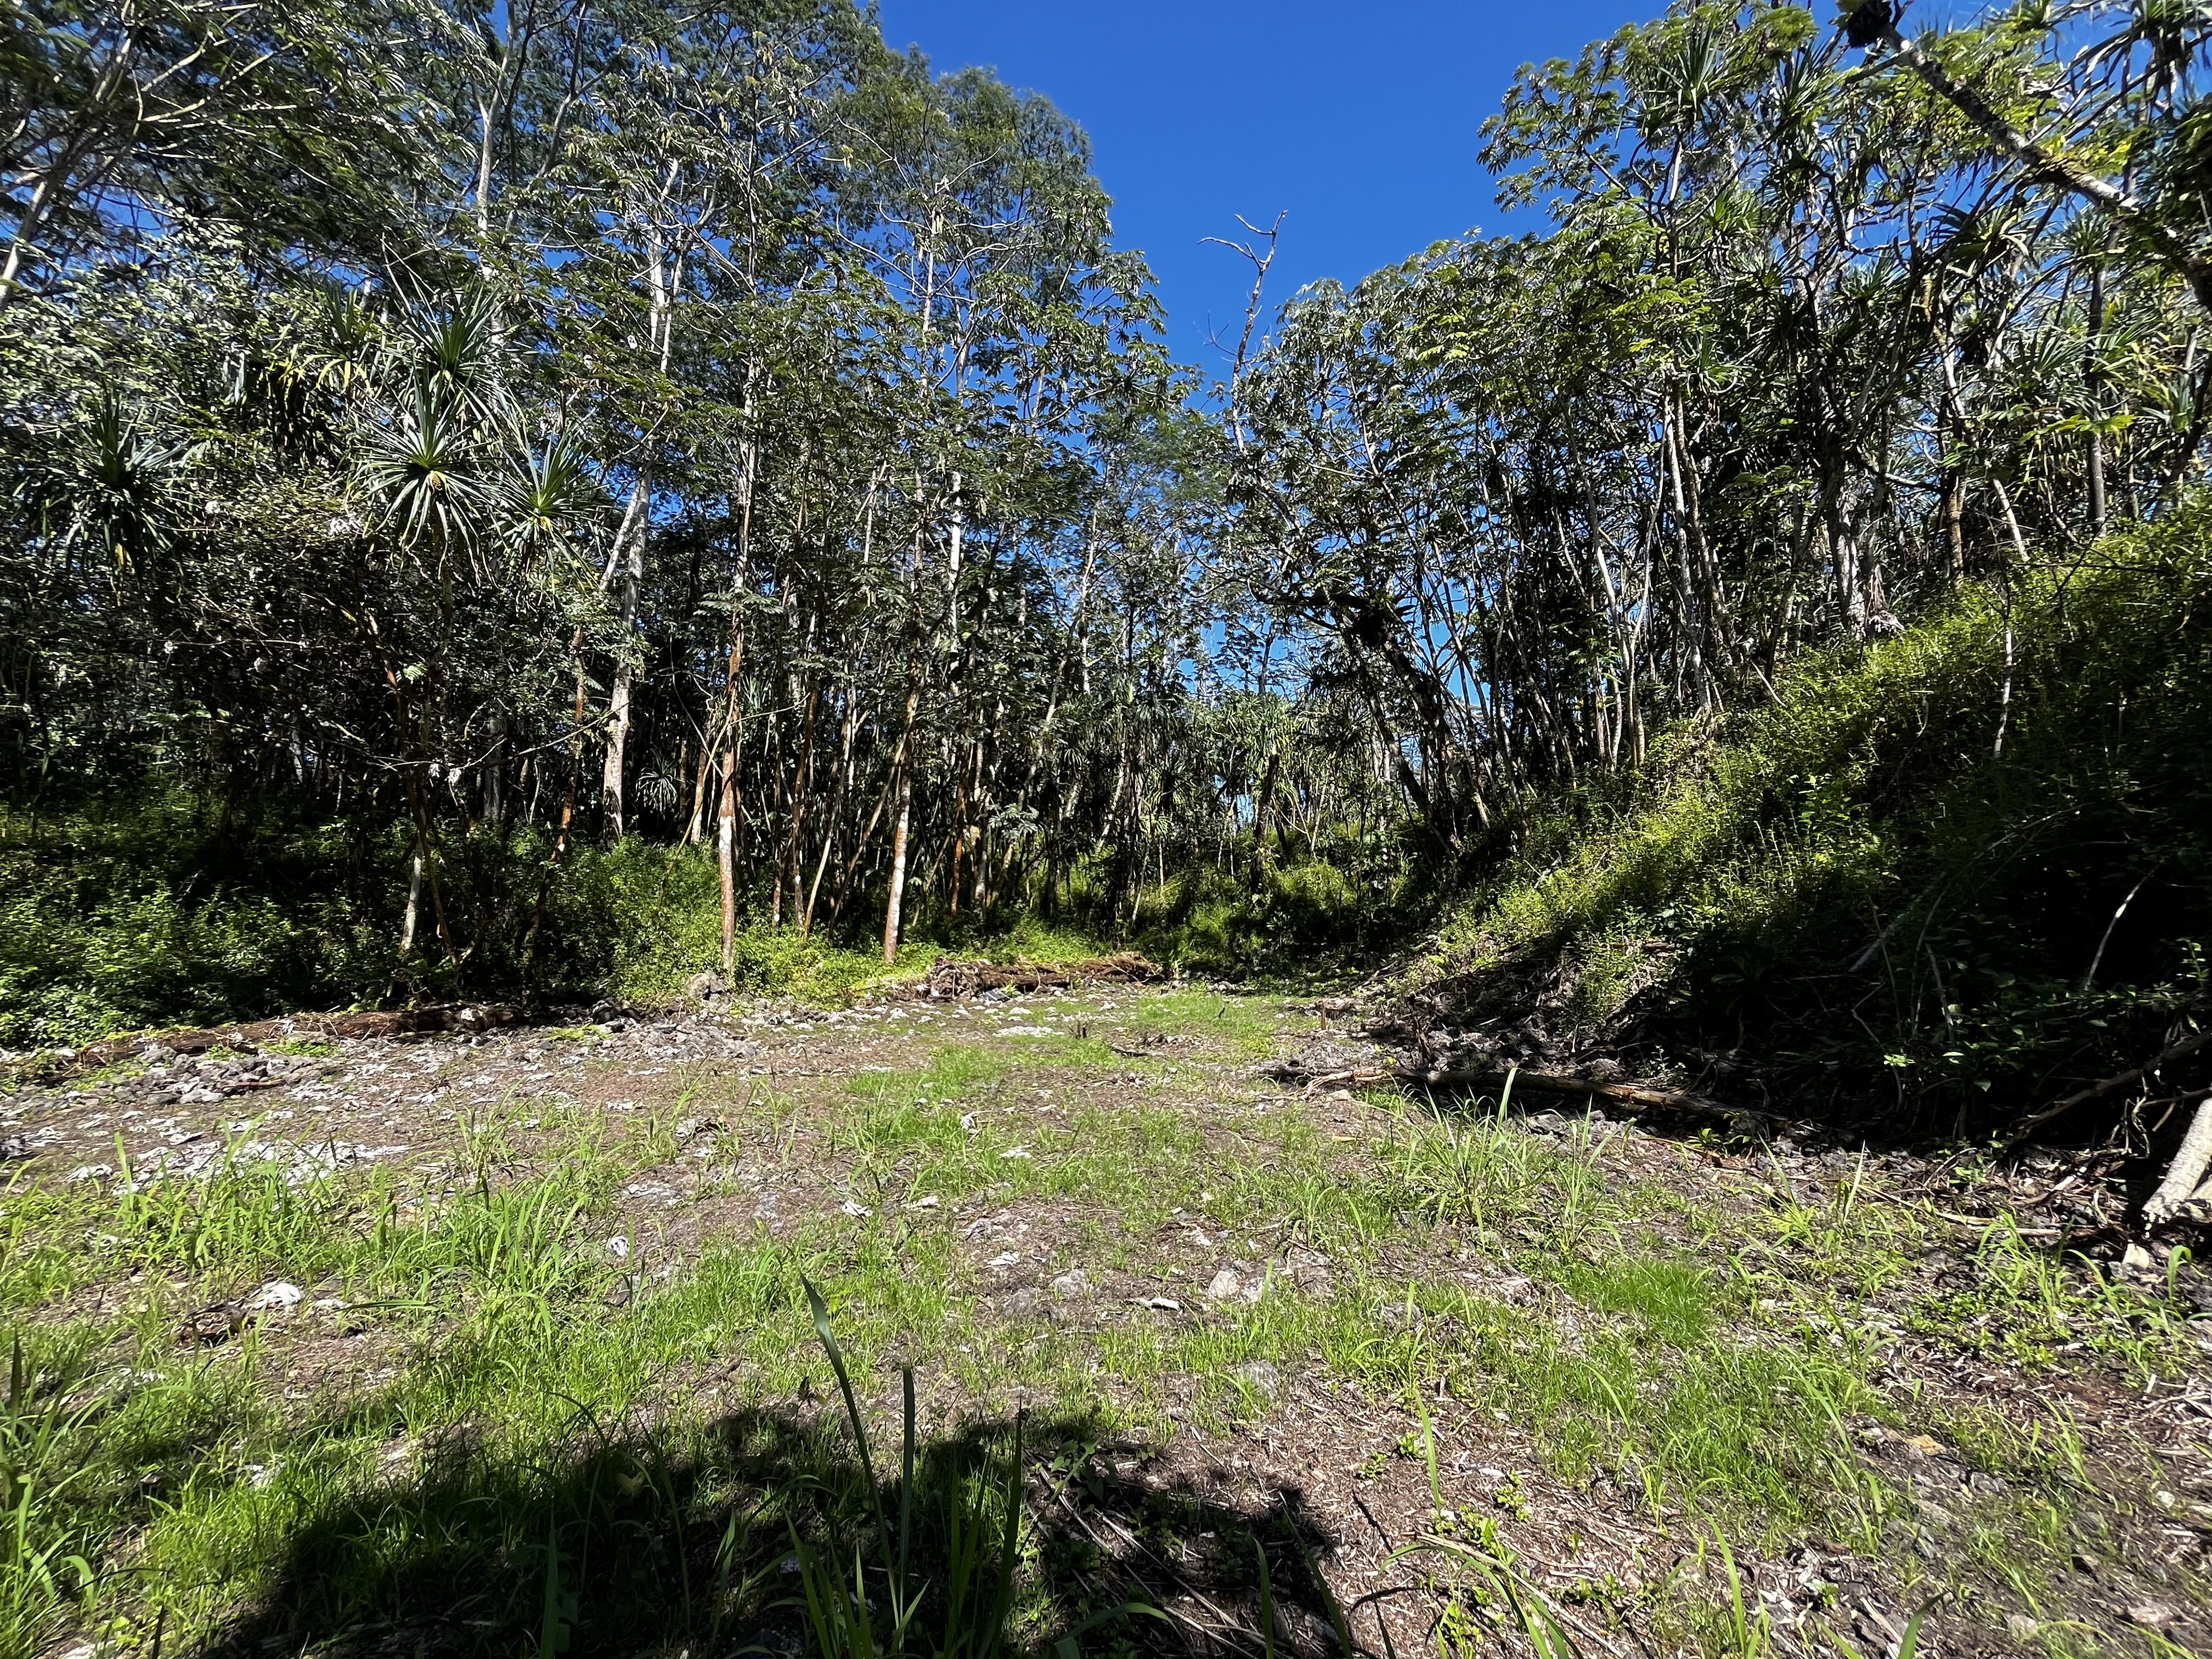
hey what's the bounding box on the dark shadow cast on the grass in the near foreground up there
[195,1404,1338,1659]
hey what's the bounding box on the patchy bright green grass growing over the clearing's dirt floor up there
[0,991,2194,1659]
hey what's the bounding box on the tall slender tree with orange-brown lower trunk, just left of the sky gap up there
[814,60,1164,956]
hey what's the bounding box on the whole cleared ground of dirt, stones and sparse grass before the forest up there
[0,986,2212,1655]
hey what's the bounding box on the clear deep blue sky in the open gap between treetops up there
[883,0,1666,371]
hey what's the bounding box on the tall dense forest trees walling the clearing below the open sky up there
[0,0,2212,989]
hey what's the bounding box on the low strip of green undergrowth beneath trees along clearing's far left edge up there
[0,789,1385,1048]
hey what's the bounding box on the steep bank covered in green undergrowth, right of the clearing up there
[1415,506,2212,1128]
